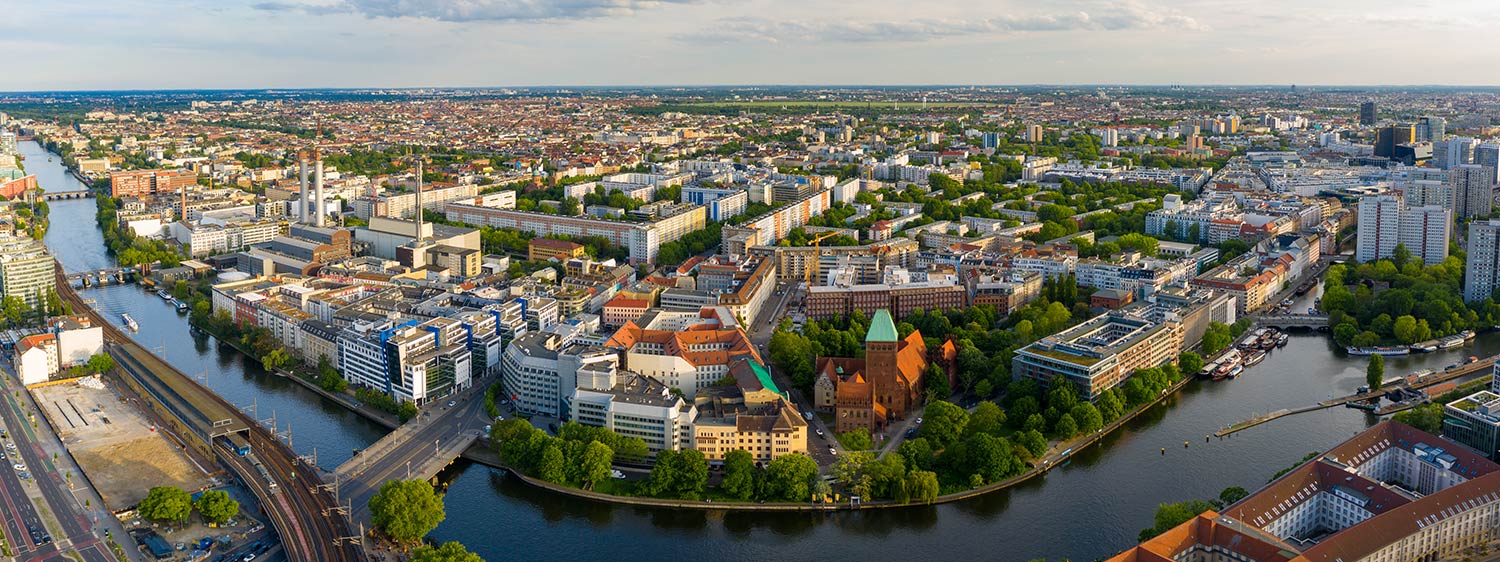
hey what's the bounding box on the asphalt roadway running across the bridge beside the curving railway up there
[339,378,494,522]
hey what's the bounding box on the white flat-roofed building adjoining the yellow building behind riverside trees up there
[567,363,698,453]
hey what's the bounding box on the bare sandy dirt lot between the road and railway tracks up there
[32,382,210,510]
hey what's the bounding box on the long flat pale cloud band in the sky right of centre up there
[675,1,1208,43]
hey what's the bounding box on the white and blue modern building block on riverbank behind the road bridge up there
[338,318,473,405]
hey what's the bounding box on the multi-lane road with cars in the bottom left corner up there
[0,375,129,562]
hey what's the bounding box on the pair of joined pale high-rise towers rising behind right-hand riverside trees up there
[1356,193,1454,265]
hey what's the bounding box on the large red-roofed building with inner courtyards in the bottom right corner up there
[1110,421,1500,562]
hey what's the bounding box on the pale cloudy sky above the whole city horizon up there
[0,0,1500,91]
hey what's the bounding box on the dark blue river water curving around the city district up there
[21,142,1500,561]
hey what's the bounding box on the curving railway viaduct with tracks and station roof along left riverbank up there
[56,264,366,561]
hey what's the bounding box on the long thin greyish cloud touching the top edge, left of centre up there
[252,0,698,22]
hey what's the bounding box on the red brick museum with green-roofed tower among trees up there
[813,310,929,435]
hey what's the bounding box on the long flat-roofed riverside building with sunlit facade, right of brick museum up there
[1011,310,1182,400]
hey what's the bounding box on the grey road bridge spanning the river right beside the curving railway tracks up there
[327,379,489,523]
